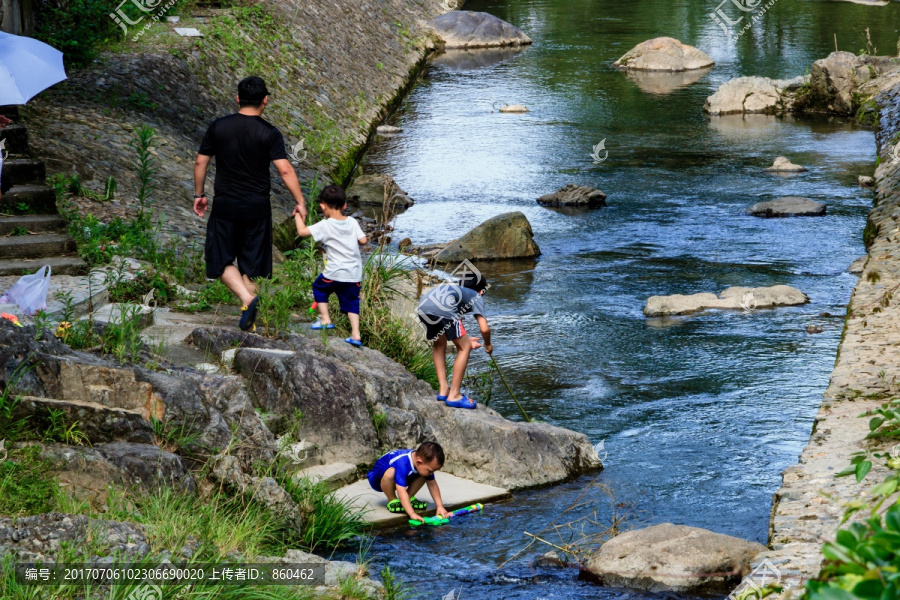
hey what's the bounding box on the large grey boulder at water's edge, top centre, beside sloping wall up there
[427,10,531,48]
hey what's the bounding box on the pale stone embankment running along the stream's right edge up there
[738,77,900,600]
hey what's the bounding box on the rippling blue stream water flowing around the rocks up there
[336,0,900,600]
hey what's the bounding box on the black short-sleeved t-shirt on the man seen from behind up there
[199,113,287,219]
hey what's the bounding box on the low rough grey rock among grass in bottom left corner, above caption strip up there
[0,512,151,562]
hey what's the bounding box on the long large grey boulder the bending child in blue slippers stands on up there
[191,328,602,489]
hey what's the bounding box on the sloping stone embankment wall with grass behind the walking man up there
[22,0,445,243]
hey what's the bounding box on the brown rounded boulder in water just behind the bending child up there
[434,211,541,263]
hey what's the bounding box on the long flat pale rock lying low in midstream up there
[644,285,809,317]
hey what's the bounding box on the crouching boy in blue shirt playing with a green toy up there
[368,442,450,522]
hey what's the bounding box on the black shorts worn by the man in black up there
[205,214,272,279]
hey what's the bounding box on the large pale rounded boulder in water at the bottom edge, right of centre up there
[585,523,766,592]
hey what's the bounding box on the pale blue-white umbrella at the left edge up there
[0,31,66,106]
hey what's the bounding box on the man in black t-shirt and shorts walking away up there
[194,77,306,331]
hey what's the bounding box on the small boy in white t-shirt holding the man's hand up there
[294,185,368,346]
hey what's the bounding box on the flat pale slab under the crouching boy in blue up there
[335,472,509,528]
